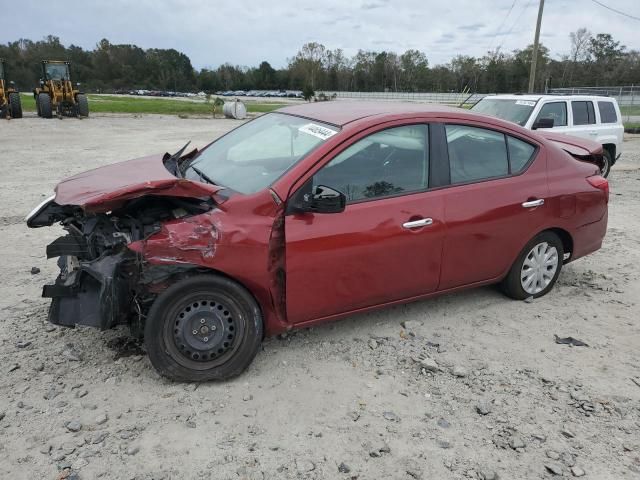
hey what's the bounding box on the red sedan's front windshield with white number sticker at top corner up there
[186,113,338,194]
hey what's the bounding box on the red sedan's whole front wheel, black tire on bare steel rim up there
[144,275,263,382]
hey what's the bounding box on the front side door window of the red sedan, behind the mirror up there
[313,124,429,203]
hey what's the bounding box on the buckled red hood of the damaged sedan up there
[54,154,222,212]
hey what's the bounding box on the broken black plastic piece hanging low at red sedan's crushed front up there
[42,252,133,330]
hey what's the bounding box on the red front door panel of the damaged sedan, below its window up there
[285,192,444,323]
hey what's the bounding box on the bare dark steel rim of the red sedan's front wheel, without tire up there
[173,299,236,362]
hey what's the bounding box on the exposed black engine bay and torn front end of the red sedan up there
[27,196,214,334]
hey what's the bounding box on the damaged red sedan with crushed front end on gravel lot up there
[27,102,609,381]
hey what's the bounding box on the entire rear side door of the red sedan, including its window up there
[440,123,548,290]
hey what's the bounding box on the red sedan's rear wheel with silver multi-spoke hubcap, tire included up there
[502,232,564,300]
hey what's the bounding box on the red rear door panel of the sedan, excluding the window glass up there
[440,150,553,290]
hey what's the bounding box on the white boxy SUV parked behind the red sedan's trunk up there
[472,95,624,177]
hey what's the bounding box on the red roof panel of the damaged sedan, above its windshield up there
[278,100,473,127]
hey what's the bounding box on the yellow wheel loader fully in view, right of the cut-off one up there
[33,60,89,118]
